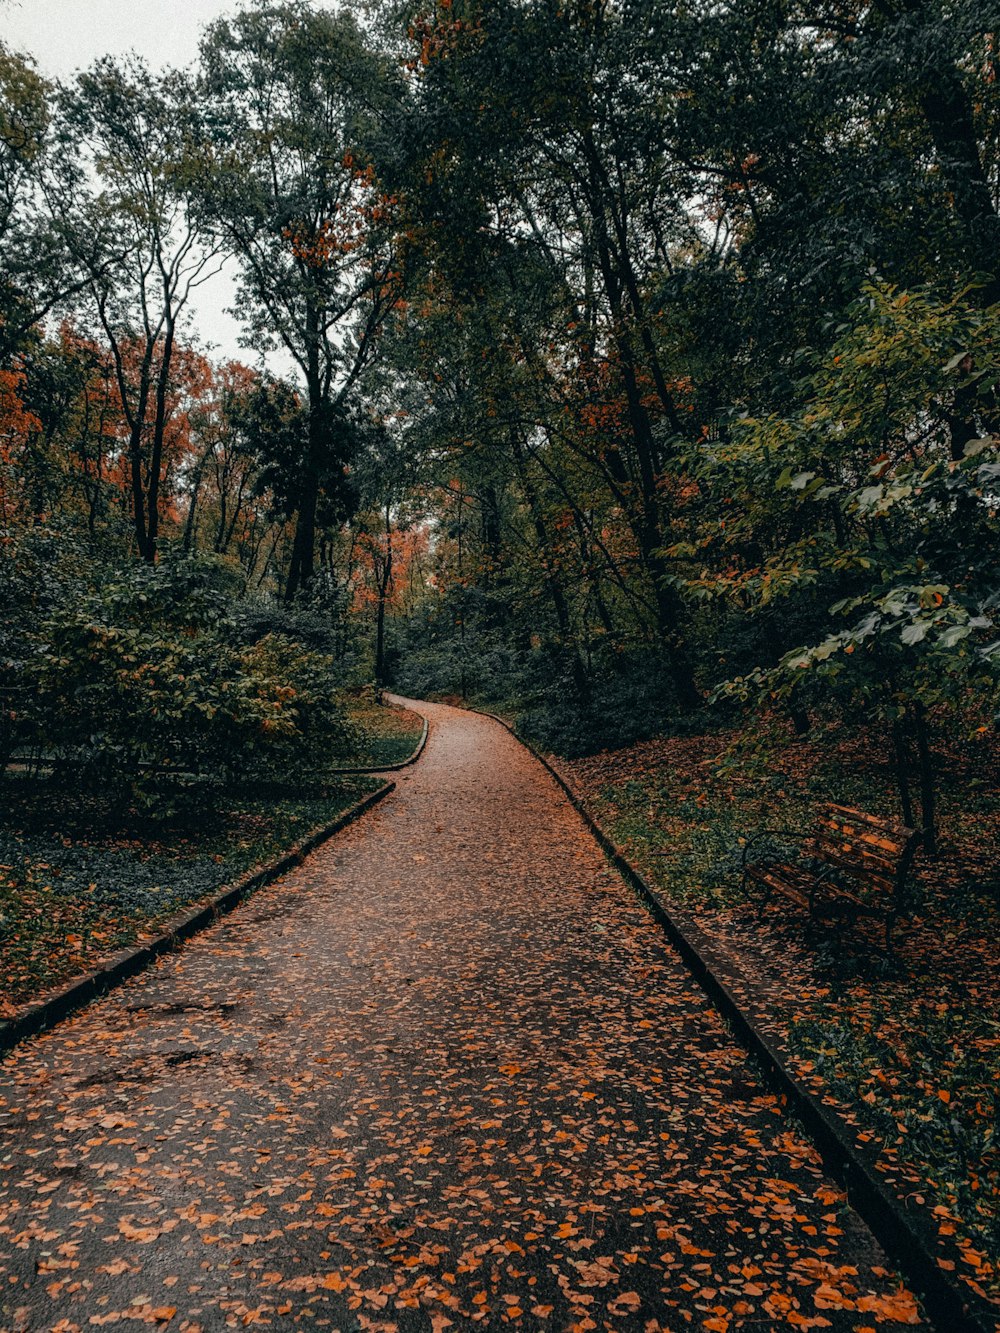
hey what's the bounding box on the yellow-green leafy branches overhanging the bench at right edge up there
[714,287,1000,735]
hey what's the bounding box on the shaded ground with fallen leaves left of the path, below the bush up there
[0,776,377,1020]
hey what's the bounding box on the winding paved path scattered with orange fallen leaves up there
[0,705,928,1333]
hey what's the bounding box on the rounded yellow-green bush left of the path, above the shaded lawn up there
[7,543,355,813]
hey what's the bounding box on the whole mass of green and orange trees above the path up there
[0,0,1000,817]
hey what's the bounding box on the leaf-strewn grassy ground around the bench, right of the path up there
[557,724,1000,1300]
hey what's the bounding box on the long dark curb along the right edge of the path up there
[471,708,1000,1333]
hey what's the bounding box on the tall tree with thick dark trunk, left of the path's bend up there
[196,0,397,600]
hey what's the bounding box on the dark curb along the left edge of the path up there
[0,782,396,1056]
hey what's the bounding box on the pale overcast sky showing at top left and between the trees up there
[0,0,268,368]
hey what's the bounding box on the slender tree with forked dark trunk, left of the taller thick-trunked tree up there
[49,57,219,563]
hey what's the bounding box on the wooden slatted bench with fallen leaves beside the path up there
[743,805,920,950]
